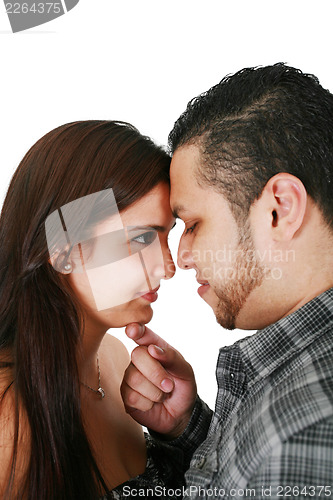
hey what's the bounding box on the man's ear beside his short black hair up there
[264,173,307,241]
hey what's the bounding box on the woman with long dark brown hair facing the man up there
[0,121,175,500]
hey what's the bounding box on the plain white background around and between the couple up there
[0,0,333,407]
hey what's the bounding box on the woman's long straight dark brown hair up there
[0,121,170,500]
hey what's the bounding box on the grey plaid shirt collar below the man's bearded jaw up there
[236,288,333,384]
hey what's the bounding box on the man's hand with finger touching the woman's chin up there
[121,323,197,439]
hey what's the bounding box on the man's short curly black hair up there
[169,63,333,228]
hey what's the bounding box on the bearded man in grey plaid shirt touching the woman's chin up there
[122,64,333,498]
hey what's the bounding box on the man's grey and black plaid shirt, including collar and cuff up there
[160,289,333,499]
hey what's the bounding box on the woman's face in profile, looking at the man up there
[68,183,175,329]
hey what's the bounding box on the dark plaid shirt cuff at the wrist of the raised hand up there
[149,396,213,473]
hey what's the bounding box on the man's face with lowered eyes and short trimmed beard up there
[170,146,265,329]
